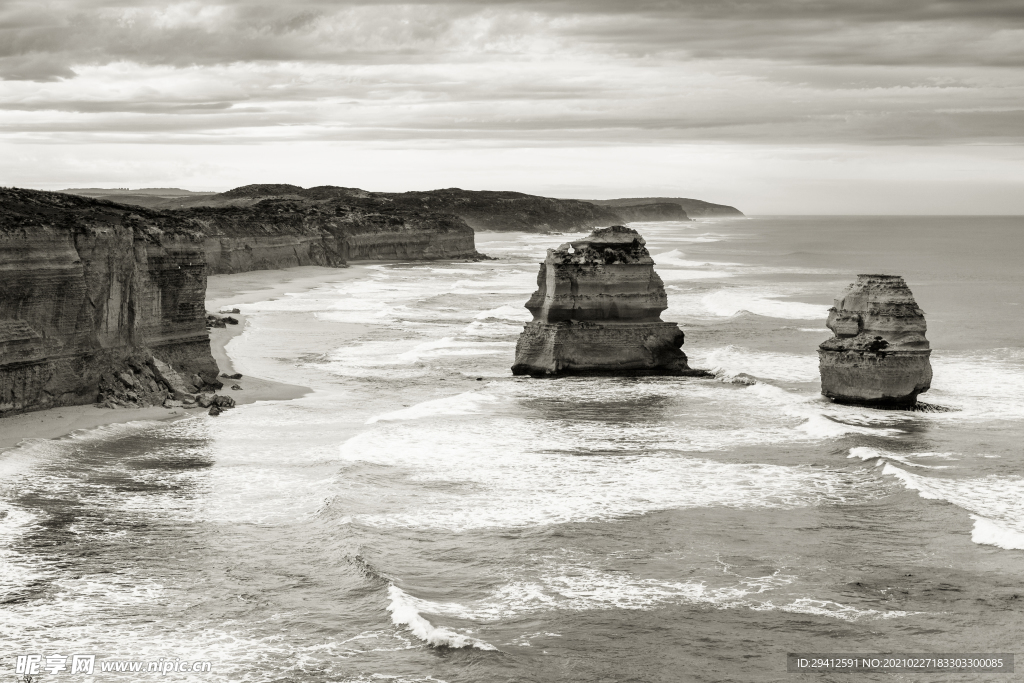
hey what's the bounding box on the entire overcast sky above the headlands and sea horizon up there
[0,0,1024,214]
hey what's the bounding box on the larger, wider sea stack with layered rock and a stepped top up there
[512,225,706,377]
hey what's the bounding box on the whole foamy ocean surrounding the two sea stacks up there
[0,217,1024,683]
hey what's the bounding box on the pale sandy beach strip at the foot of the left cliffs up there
[0,262,370,452]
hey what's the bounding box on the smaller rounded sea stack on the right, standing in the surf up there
[818,275,932,408]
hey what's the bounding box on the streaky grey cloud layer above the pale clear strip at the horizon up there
[0,0,1024,210]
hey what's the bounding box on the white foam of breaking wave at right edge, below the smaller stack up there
[882,463,1024,550]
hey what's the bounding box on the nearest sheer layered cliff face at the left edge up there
[0,189,217,416]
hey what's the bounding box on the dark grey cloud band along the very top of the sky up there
[0,0,1024,78]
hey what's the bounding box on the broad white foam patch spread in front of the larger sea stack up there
[340,380,900,530]
